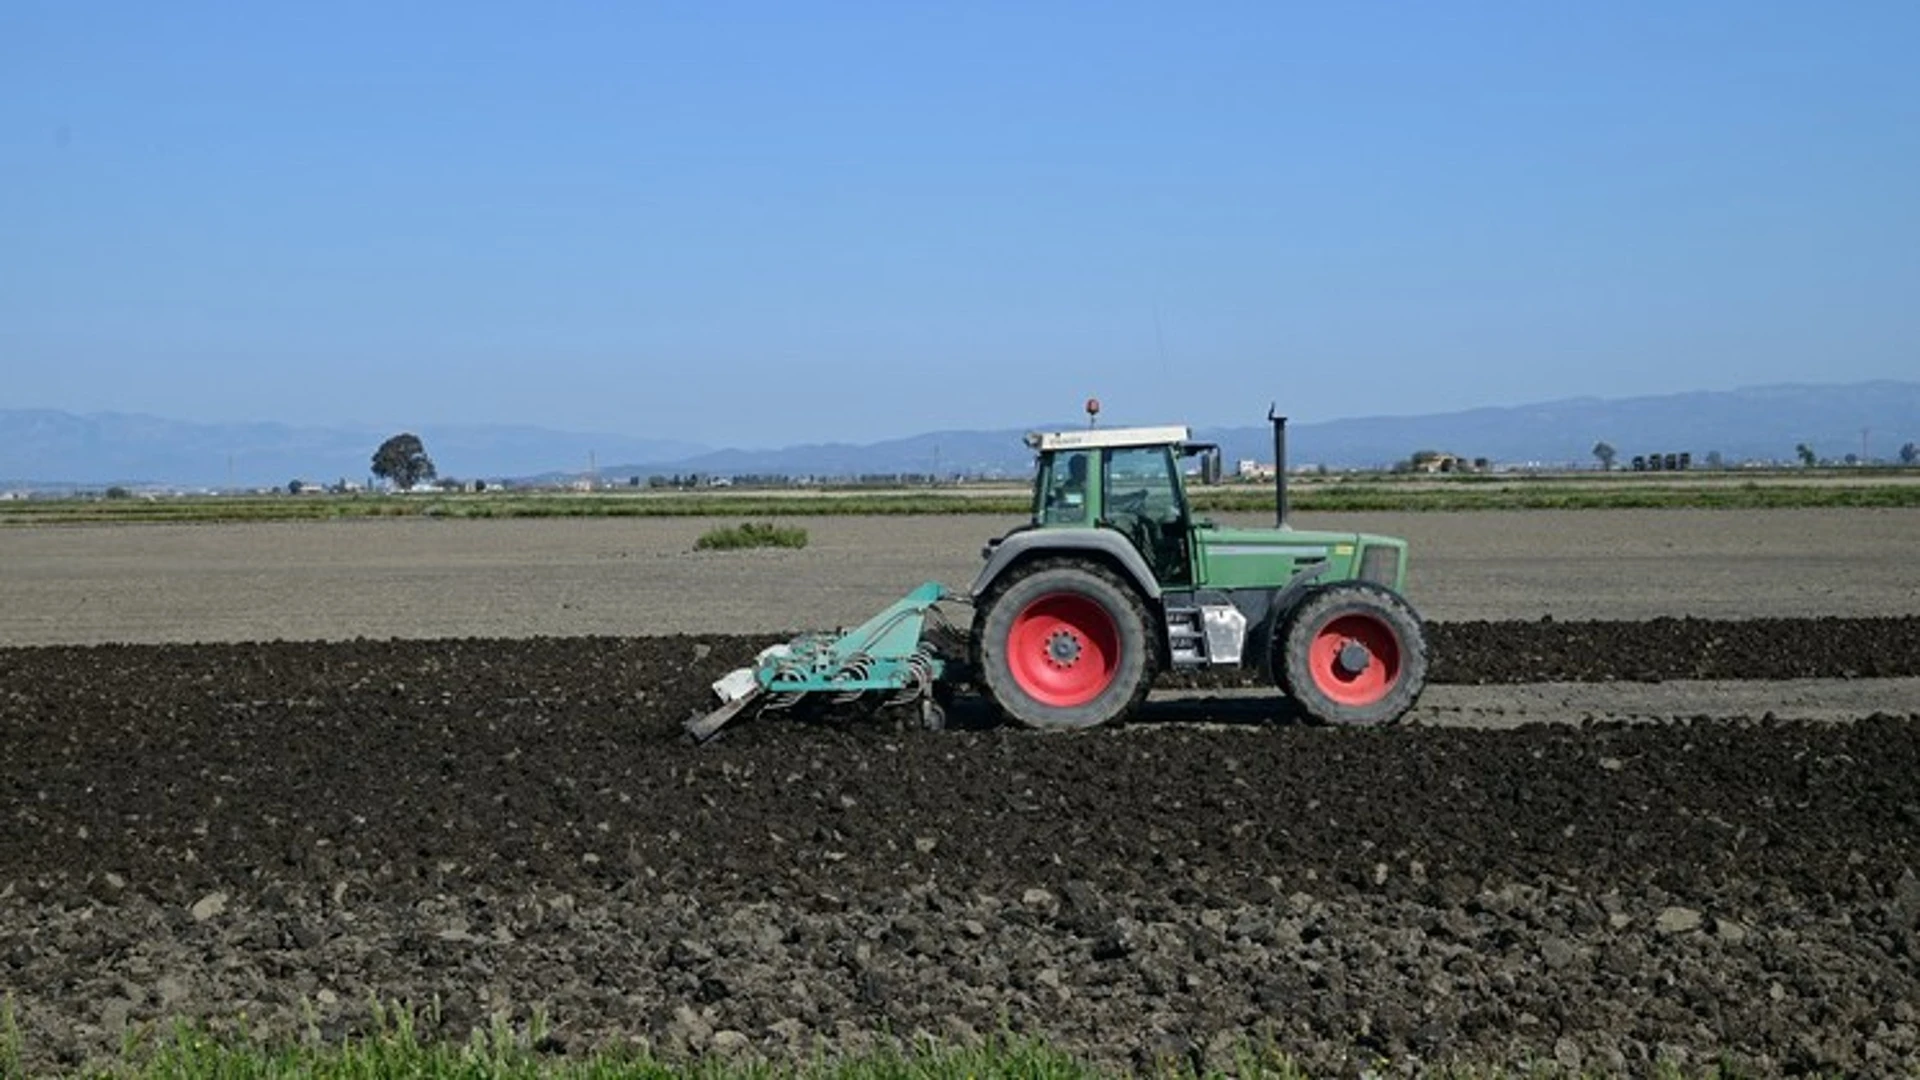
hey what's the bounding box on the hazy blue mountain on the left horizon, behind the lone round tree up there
[0,409,707,488]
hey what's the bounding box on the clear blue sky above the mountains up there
[0,0,1920,446]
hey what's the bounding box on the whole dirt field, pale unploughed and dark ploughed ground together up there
[0,513,1920,1076]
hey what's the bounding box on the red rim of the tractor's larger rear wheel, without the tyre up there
[1006,592,1119,709]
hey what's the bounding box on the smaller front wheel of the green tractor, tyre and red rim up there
[1273,580,1427,726]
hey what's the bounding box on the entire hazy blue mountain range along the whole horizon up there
[0,380,1920,490]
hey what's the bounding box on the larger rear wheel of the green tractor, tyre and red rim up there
[973,559,1154,730]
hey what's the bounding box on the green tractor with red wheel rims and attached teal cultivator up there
[687,402,1427,740]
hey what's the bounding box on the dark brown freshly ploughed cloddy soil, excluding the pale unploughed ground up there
[0,619,1920,1074]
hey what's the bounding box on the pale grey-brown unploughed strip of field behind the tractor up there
[0,509,1920,646]
